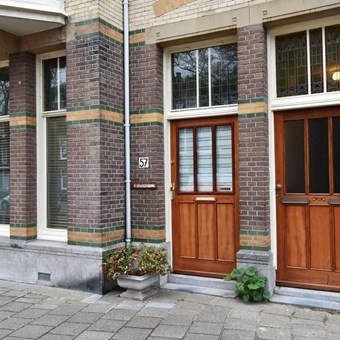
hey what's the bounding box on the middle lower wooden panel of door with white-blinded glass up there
[197,203,216,260]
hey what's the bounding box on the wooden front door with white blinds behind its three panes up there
[171,117,239,277]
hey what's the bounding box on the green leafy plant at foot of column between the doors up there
[224,267,271,302]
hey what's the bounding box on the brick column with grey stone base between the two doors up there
[237,25,274,288]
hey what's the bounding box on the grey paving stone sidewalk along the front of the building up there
[0,281,340,340]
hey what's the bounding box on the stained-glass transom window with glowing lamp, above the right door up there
[275,25,340,97]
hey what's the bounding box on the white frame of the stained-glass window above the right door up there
[268,16,340,111]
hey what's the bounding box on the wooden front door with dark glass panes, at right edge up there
[275,107,340,291]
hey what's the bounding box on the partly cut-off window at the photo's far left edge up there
[0,66,10,224]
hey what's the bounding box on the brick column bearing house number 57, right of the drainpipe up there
[130,37,165,243]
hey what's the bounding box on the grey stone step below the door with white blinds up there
[162,274,236,297]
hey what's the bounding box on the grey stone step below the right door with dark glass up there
[270,287,340,311]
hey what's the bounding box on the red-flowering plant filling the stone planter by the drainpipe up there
[102,245,171,280]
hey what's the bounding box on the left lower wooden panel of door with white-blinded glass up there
[178,202,197,258]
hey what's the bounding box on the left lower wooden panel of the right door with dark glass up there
[285,205,307,268]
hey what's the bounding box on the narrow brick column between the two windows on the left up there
[9,53,37,240]
